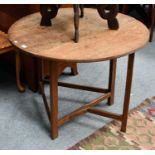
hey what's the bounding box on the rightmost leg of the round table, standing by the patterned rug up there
[121,53,135,132]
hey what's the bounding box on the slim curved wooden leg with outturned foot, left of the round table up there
[15,51,25,92]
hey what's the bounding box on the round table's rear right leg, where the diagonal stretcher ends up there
[108,59,117,105]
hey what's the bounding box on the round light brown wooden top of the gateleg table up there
[9,8,149,62]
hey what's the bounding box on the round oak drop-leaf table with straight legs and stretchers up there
[9,8,149,139]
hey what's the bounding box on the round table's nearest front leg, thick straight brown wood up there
[50,62,58,139]
